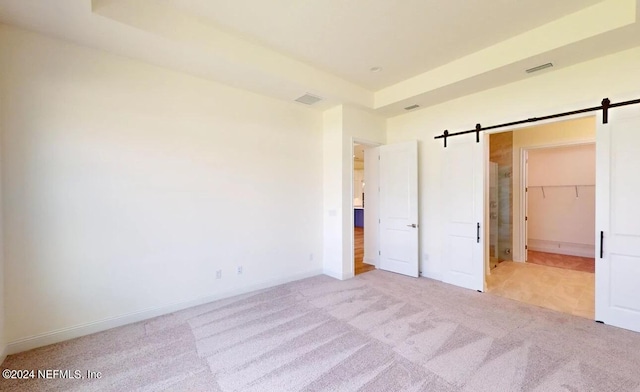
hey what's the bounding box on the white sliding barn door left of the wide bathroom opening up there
[442,135,485,291]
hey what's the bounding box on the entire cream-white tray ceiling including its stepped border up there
[0,0,640,116]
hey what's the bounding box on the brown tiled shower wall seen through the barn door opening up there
[489,132,513,261]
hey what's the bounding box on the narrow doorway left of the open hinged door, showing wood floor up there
[352,143,377,275]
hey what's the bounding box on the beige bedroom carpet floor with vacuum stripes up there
[0,271,640,392]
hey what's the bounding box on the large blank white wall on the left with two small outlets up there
[0,26,322,351]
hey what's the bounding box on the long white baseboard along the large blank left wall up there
[6,269,323,356]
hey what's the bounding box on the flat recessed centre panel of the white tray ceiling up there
[165,0,599,91]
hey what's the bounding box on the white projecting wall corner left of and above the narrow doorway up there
[323,105,386,279]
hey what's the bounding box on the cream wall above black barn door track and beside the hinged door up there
[387,44,640,279]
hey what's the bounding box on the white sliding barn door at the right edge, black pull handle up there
[595,105,640,332]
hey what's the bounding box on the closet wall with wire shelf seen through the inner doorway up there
[527,144,596,257]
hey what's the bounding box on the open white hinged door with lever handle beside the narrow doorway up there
[380,141,419,277]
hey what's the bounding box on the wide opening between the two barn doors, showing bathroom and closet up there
[486,117,596,319]
